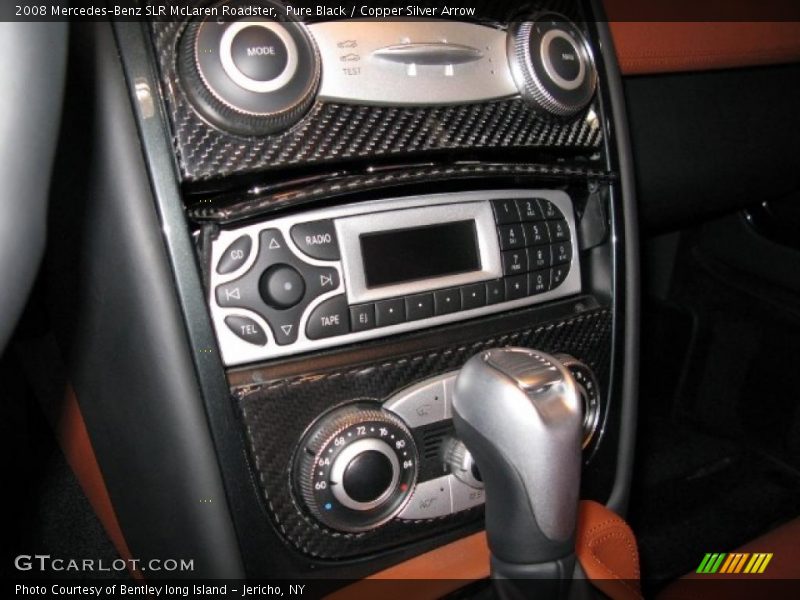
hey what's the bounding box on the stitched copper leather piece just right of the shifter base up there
[575,500,642,600]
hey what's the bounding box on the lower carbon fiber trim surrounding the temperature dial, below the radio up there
[234,308,612,559]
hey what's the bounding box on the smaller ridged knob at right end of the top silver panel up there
[508,13,597,117]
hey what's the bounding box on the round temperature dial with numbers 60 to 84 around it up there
[295,403,417,531]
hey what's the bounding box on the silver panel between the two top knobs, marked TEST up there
[309,20,519,105]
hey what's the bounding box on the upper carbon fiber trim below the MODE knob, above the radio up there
[150,3,602,181]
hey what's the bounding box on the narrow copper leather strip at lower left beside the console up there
[56,385,143,579]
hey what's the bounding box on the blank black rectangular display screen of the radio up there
[359,221,481,288]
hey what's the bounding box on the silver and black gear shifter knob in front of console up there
[453,348,582,578]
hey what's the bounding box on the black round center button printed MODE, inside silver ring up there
[231,24,289,81]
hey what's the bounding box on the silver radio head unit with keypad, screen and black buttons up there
[209,190,581,366]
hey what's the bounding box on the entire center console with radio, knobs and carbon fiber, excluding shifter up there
[94,0,635,578]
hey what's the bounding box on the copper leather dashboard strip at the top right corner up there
[604,0,800,75]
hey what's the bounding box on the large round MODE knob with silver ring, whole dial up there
[178,0,320,135]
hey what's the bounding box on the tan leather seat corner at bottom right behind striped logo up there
[658,518,800,600]
